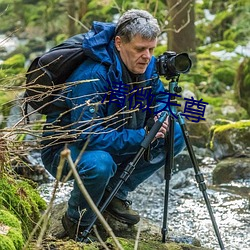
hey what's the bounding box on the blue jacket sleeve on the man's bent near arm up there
[66,61,146,155]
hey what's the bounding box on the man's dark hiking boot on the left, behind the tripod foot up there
[62,213,97,243]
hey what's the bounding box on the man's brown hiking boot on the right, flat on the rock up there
[105,197,140,225]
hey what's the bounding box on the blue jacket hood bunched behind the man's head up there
[82,21,116,65]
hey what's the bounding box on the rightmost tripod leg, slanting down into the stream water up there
[178,113,225,250]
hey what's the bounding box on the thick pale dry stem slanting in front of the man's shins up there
[61,149,124,250]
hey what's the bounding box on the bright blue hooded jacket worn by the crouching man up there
[44,22,167,155]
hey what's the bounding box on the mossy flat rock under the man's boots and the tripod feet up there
[43,202,209,250]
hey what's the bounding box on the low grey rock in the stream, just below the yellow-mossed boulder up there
[213,157,250,184]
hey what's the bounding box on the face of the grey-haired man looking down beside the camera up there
[115,35,157,74]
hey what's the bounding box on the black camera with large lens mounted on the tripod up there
[156,51,192,80]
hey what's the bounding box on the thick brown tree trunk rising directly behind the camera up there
[167,0,196,61]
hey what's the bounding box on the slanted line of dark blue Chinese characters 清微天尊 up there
[101,81,208,122]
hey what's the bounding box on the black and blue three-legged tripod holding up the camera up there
[82,78,225,250]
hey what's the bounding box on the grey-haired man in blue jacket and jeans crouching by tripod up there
[42,10,184,239]
